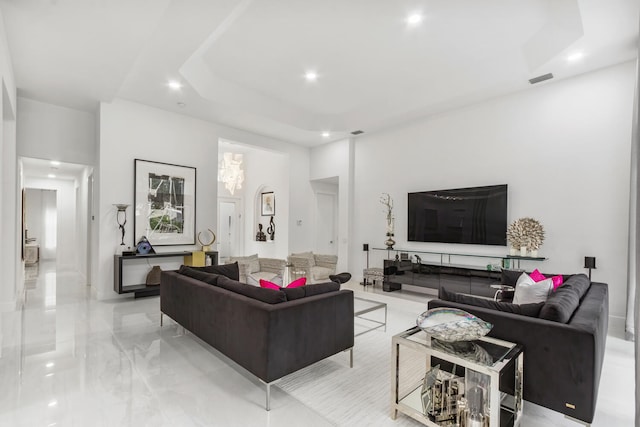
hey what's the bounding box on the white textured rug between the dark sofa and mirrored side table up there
[276,330,422,427]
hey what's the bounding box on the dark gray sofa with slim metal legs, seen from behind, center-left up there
[160,271,354,410]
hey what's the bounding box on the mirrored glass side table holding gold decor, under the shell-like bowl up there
[391,327,524,427]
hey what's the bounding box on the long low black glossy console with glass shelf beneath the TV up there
[373,248,546,297]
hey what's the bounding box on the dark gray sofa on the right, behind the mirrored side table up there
[429,274,609,424]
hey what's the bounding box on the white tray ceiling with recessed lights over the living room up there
[0,0,639,146]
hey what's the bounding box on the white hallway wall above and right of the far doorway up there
[24,176,78,271]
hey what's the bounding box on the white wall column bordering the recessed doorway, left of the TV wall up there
[310,139,354,271]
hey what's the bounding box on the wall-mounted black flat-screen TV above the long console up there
[407,184,507,246]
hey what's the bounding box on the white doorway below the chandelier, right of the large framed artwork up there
[218,197,244,264]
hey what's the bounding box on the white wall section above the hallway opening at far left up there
[18,97,97,166]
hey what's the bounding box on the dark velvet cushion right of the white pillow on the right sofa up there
[540,274,591,323]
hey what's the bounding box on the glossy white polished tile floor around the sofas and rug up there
[0,262,634,427]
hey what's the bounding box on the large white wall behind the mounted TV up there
[350,62,635,330]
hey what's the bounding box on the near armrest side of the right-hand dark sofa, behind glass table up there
[429,300,606,423]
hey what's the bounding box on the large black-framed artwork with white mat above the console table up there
[133,159,196,246]
